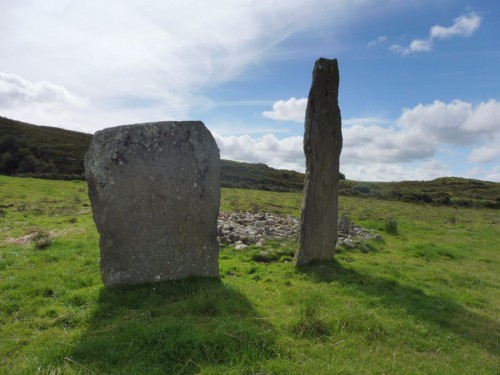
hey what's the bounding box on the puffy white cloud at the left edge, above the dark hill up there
[0,72,86,108]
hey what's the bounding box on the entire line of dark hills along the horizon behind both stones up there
[0,117,500,209]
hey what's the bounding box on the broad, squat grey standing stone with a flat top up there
[85,121,220,287]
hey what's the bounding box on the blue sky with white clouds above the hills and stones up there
[0,0,500,182]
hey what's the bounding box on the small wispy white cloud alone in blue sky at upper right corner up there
[389,12,482,56]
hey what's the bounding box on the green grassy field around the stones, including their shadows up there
[0,176,500,375]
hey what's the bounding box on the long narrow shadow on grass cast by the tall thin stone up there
[299,260,500,354]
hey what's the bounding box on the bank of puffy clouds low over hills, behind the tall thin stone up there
[226,100,500,181]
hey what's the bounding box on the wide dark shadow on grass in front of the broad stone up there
[71,278,277,374]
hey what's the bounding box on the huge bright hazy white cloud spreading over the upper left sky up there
[0,0,369,130]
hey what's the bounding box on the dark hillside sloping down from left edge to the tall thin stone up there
[0,117,304,191]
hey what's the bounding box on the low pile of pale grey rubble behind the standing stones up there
[217,212,383,249]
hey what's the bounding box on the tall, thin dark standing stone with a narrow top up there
[295,58,342,266]
